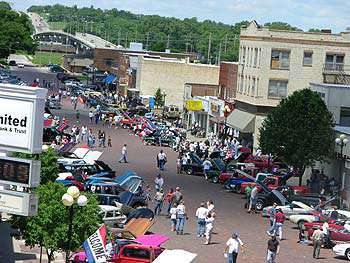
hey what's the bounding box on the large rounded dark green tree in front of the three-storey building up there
[260,89,333,185]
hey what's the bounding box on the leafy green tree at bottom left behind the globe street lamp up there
[10,182,102,262]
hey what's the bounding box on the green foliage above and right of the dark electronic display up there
[12,148,59,184]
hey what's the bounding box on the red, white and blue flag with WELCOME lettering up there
[83,225,107,263]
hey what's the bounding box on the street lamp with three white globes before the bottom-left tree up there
[62,186,88,263]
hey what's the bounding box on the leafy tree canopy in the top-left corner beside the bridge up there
[0,8,36,58]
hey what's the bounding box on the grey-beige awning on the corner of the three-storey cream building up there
[227,109,255,133]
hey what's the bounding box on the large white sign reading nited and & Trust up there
[0,84,47,153]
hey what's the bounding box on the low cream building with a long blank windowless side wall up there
[136,56,219,108]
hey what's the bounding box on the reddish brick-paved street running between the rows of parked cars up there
[5,67,342,263]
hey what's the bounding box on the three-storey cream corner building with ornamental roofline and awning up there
[228,21,350,149]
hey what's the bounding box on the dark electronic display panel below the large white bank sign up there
[0,157,41,188]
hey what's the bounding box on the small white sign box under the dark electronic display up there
[0,190,38,216]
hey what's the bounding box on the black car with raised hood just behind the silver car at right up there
[256,186,324,210]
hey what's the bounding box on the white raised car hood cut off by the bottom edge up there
[153,249,197,263]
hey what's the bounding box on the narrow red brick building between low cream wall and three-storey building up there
[219,61,238,101]
